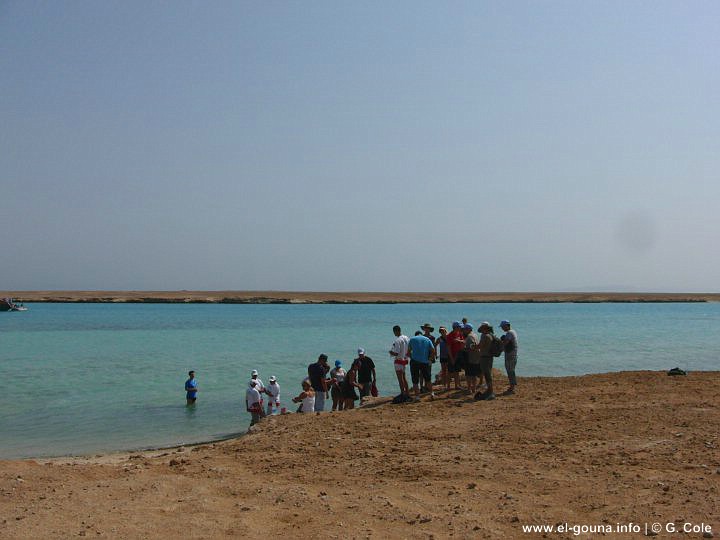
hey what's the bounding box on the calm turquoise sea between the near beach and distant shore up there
[0,303,720,458]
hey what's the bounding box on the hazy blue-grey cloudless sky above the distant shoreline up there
[0,0,720,291]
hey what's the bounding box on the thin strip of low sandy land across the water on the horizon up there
[0,291,720,304]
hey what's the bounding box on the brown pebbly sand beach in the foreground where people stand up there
[0,372,720,539]
